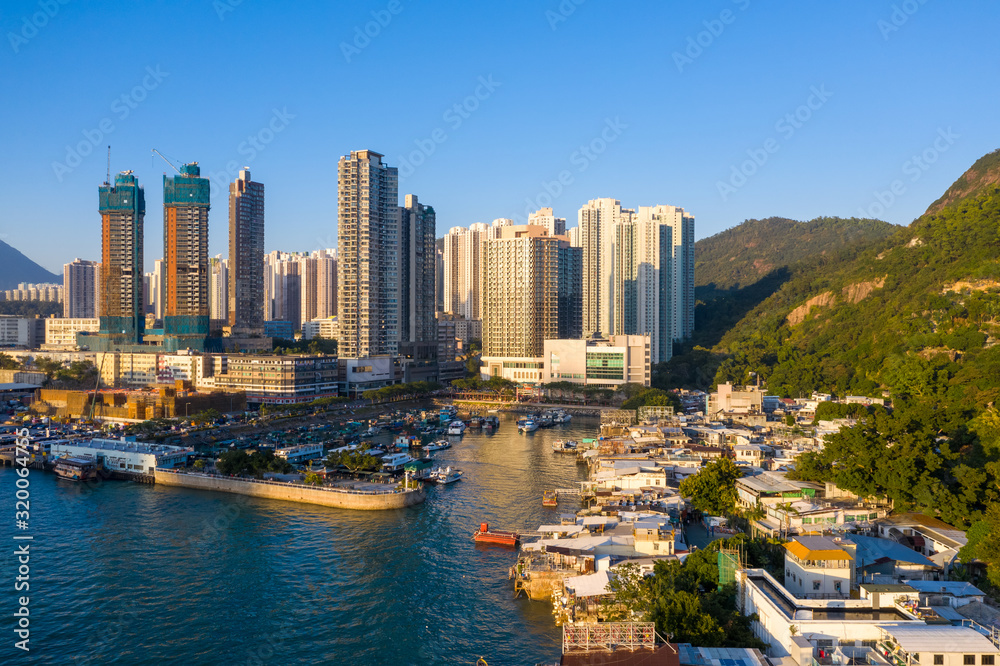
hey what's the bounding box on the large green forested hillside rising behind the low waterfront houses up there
[659,152,1000,576]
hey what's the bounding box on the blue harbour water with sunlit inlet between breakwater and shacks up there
[0,416,598,666]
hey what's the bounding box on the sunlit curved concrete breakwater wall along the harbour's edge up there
[155,468,427,511]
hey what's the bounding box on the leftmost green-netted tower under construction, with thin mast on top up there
[97,171,146,344]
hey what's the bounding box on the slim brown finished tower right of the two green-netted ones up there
[229,168,264,337]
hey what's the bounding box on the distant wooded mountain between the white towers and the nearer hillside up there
[694,217,899,289]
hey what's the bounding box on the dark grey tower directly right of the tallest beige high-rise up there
[399,194,437,343]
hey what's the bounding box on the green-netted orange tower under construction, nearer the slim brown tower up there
[163,162,211,351]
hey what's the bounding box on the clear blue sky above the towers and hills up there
[0,0,1000,271]
